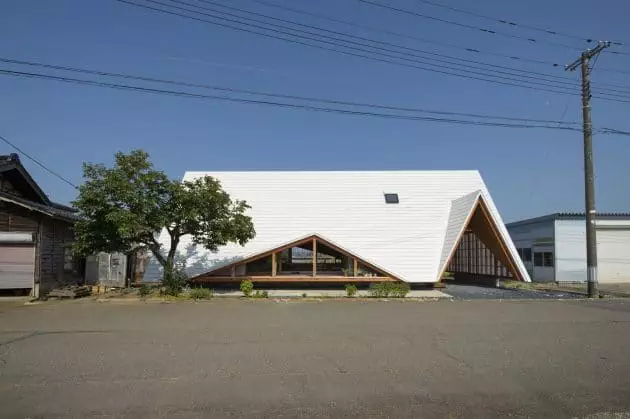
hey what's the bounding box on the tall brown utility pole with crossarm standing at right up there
[565,42,610,298]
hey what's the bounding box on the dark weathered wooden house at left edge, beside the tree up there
[0,154,85,297]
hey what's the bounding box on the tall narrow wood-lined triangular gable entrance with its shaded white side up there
[438,193,525,281]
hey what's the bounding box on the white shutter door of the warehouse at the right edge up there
[597,229,630,283]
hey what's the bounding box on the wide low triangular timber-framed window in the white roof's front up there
[192,235,399,282]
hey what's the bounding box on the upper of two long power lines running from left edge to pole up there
[0,57,579,125]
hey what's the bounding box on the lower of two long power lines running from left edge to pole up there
[0,69,580,131]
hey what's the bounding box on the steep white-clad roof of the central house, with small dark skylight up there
[156,171,528,282]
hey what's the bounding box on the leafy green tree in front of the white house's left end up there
[73,150,256,293]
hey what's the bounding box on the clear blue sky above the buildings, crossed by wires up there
[0,0,630,221]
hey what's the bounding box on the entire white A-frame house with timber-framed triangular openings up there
[153,171,529,283]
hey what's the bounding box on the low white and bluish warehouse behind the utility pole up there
[507,213,630,283]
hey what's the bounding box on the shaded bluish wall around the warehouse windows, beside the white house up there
[508,220,555,281]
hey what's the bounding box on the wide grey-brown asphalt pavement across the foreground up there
[0,299,630,418]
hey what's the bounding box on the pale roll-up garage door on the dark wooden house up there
[0,232,35,289]
